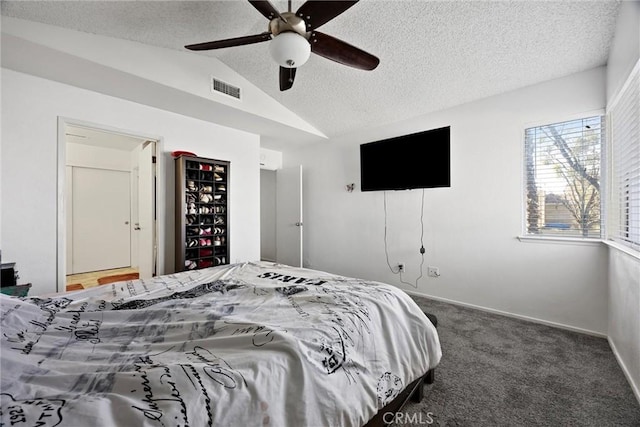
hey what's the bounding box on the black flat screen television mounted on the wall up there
[360,126,451,191]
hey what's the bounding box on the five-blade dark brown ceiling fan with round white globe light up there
[185,0,380,91]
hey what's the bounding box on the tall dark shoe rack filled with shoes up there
[175,155,230,271]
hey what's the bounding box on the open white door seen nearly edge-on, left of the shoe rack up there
[133,141,156,279]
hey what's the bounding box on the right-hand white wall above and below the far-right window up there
[607,1,640,401]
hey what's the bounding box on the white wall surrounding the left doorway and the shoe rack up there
[0,68,260,295]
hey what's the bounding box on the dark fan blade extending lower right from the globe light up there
[309,31,380,70]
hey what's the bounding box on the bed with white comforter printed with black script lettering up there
[0,262,441,427]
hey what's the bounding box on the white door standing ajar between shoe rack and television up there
[276,166,303,267]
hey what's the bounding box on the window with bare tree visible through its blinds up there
[524,116,604,239]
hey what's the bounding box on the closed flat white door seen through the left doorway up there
[72,167,131,273]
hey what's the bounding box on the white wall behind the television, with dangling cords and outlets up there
[284,67,607,334]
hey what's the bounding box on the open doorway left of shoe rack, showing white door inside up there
[57,119,159,292]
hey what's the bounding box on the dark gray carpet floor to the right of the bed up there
[394,297,640,427]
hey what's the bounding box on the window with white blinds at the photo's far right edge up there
[607,62,640,250]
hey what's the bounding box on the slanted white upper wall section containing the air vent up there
[1,16,324,149]
